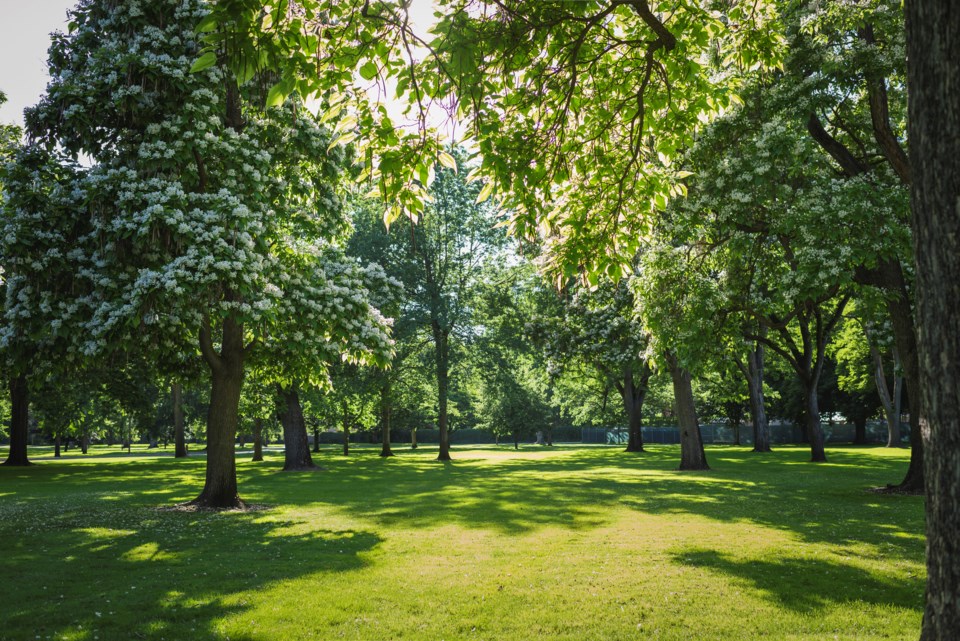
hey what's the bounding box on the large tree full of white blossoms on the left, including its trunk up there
[27,0,398,507]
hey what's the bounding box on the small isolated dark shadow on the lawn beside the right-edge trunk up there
[672,549,924,614]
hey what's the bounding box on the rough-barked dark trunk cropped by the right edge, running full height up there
[906,0,960,641]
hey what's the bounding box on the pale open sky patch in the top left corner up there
[0,0,75,124]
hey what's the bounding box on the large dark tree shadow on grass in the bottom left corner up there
[0,499,381,640]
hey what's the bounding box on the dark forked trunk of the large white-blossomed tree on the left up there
[190,318,244,509]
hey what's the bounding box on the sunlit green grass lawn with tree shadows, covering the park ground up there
[0,446,924,641]
